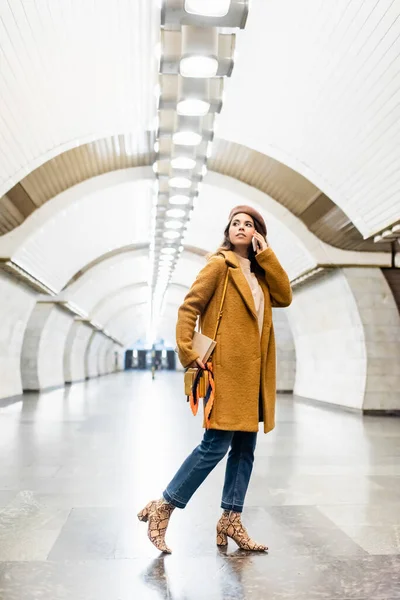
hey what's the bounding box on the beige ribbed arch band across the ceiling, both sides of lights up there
[0,135,389,252]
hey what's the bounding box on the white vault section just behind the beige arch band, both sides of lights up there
[0,167,388,304]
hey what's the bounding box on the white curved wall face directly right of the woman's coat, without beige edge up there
[287,270,367,409]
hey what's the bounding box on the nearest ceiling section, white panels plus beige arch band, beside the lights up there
[0,0,400,251]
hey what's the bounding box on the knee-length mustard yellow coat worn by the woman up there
[176,248,292,433]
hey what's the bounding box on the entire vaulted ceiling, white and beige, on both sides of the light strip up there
[0,0,400,343]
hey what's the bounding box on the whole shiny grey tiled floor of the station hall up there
[0,373,400,600]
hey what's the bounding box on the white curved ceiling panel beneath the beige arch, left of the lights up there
[0,172,152,292]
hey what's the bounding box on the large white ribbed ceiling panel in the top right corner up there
[218,0,400,237]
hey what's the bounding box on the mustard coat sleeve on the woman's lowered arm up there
[176,256,226,368]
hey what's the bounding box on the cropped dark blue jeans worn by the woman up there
[163,429,257,512]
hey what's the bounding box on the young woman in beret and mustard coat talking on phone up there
[138,206,292,553]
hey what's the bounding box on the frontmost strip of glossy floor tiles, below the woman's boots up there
[0,553,400,600]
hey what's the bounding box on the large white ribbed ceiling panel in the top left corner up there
[0,0,160,196]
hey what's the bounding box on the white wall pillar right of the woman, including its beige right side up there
[287,268,400,410]
